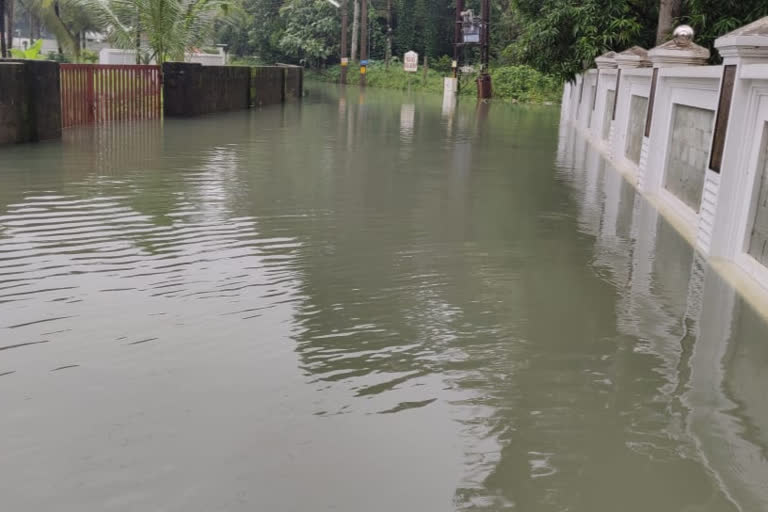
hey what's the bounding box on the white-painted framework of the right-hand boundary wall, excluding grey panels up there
[561,17,768,295]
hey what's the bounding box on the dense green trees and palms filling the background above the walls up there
[5,0,768,79]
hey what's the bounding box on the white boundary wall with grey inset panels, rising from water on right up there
[561,17,768,308]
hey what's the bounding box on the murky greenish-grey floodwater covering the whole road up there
[0,87,768,512]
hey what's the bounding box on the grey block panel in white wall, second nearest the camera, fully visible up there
[664,105,715,212]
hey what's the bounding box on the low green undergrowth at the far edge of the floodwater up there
[307,62,562,103]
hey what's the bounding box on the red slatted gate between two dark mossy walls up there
[61,64,163,128]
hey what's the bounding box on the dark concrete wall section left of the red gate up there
[0,59,61,144]
